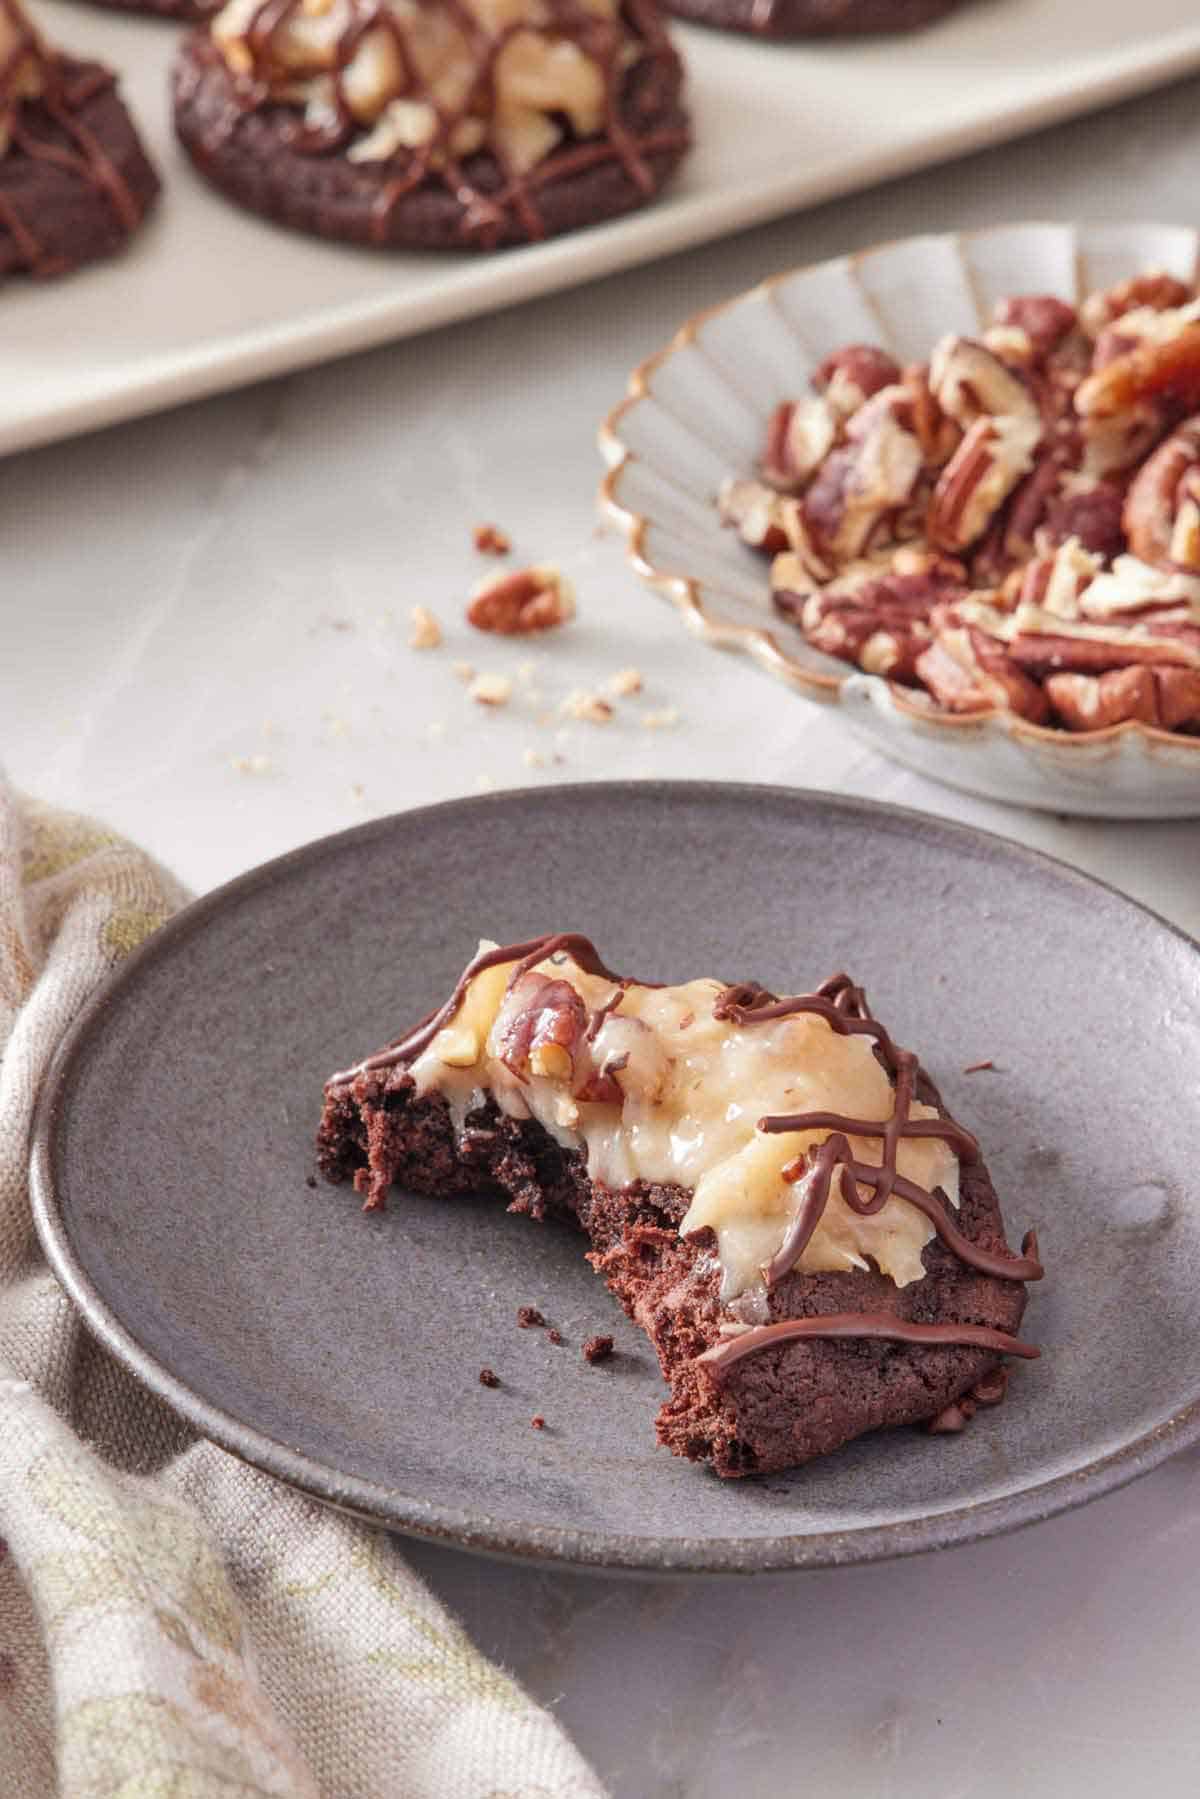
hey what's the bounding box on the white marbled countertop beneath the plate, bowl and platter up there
[0,66,1200,1799]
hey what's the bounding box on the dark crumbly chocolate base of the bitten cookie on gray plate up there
[317,1069,1025,1477]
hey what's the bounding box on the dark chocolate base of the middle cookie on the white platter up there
[171,32,687,250]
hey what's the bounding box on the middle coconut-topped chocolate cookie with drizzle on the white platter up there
[175,0,689,250]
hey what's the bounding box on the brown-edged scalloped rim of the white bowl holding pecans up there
[596,218,1200,772]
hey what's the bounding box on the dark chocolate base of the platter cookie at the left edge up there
[0,58,158,279]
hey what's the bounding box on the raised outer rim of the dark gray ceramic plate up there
[29,779,1200,1576]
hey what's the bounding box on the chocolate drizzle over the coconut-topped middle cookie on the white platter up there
[209,0,689,246]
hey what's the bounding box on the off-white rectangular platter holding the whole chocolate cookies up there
[0,0,1200,452]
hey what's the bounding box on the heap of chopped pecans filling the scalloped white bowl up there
[712,270,1200,734]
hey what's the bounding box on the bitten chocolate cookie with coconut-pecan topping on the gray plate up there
[317,934,1042,1475]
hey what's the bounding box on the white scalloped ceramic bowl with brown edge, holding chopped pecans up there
[599,225,1200,819]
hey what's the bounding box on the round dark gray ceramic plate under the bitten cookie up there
[34,784,1200,1571]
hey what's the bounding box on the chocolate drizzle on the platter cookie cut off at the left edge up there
[0,0,142,277]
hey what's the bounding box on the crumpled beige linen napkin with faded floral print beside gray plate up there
[0,774,604,1799]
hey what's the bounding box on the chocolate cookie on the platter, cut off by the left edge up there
[0,0,158,277]
